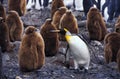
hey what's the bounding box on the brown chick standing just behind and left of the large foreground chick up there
[7,10,24,42]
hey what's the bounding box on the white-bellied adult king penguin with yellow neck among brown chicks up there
[51,28,90,71]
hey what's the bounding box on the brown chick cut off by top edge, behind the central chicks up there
[51,0,65,18]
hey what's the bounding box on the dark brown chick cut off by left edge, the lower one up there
[0,17,14,52]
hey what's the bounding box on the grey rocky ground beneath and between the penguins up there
[2,0,120,79]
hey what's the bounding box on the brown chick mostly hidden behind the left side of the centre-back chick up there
[52,7,68,29]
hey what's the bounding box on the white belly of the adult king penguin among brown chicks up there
[68,36,90,69]
